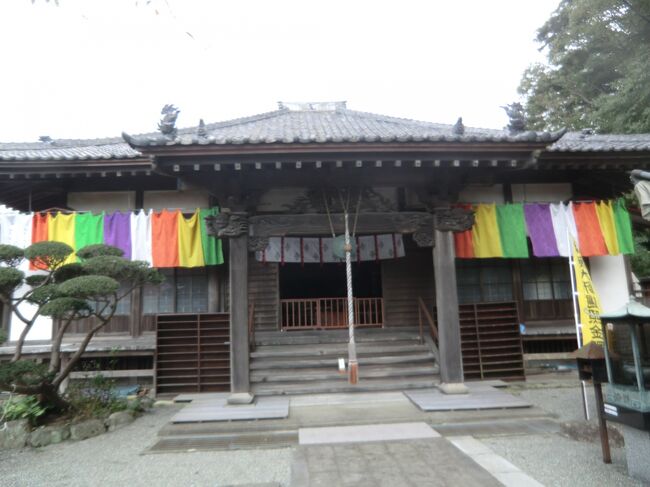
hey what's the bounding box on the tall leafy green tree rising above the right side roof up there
[519,0,650,133]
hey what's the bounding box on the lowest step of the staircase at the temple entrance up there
[251,376,439,396]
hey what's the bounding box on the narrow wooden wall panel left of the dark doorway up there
[248,260,280,330]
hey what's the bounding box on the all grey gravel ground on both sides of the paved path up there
[0,374,644,487]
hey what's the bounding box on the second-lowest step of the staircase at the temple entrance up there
[250,363,439,383]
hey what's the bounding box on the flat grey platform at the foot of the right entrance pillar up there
[404,383,532,411]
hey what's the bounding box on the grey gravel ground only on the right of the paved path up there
[481,376,645,487]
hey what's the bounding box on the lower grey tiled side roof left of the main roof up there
[0,138,142,161]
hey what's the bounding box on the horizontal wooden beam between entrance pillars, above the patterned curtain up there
[249,212,433,237]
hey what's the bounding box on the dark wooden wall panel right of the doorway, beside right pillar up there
[381,248,435,327]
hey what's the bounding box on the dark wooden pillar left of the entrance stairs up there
[229,233,250,394]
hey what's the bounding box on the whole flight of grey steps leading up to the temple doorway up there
[250,328,439,395]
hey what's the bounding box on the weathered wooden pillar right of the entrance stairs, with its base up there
[433,230,467,393]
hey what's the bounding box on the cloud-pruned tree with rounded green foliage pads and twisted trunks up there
[0,242,163,409]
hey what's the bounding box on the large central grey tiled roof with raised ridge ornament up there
[124,102,560,148]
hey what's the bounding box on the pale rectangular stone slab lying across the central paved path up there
[298,423,440,445]
